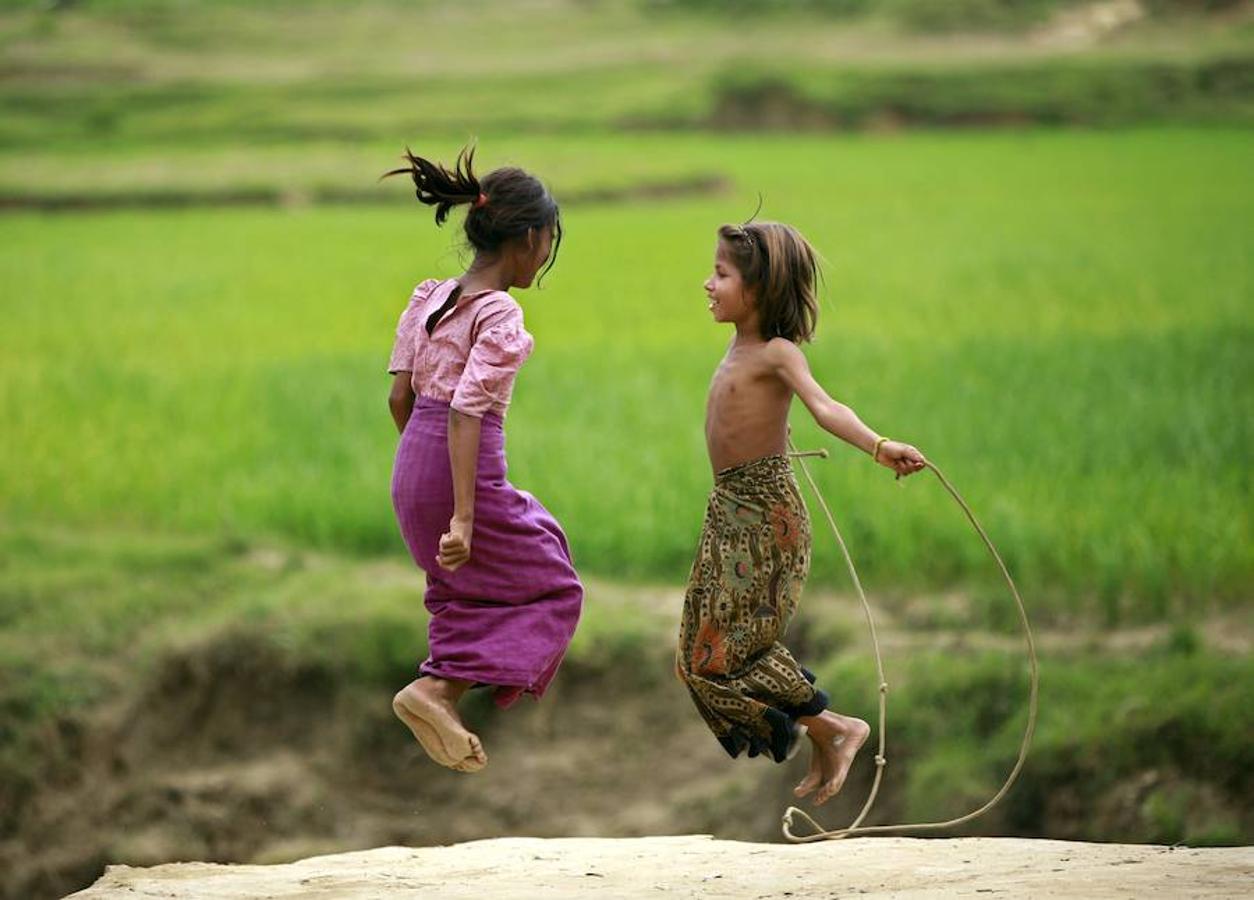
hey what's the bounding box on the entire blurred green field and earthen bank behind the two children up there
[0,0,1254,896]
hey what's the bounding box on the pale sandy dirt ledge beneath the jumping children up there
[73,835,1254,900]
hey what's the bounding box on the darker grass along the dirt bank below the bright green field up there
[0,528,1254,845]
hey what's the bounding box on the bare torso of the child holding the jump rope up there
[706,342,793,473]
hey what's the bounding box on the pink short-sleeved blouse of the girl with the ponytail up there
[387,278,535,419]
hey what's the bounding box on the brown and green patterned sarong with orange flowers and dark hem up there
[676,456,828,762]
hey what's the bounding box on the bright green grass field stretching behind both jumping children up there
[0,130,1254,623]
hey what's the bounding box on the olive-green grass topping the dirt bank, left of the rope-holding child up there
[0,526,672,802]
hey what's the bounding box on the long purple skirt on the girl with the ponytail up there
[391,397,583,707]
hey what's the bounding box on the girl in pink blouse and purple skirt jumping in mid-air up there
[387,149,583,772]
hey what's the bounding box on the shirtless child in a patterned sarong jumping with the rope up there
[677,222,924,803]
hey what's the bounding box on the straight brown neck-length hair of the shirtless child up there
[719,222,819,343]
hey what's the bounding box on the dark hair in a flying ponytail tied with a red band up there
[382,147,562,278]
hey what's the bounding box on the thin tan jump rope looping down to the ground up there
[781,437,1040,844]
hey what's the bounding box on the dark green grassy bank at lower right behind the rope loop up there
[820,642,1254,846]
